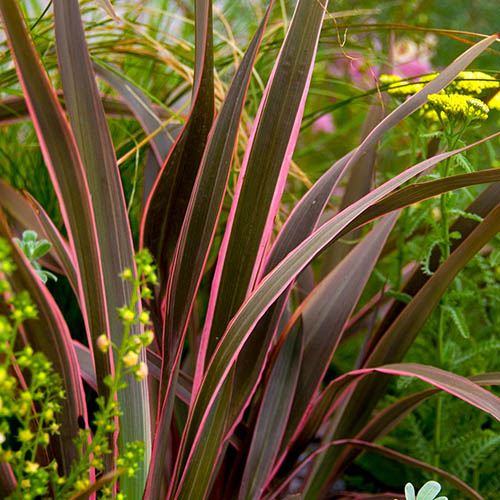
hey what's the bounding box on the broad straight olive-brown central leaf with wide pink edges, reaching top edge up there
[195,1,328,376]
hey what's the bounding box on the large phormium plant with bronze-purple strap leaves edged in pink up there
[0,0,500,499]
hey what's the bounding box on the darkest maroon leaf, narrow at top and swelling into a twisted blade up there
[140,0,214,292]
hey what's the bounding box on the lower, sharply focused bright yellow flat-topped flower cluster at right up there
[428,94,490,120]
